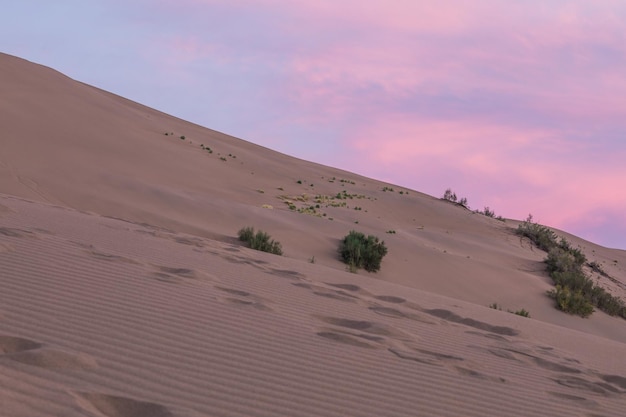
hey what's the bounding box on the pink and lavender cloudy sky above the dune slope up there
[0,0,626,249]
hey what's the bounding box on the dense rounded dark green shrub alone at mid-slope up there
[339,230,387,272]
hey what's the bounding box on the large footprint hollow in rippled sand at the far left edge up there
[0,336,98,369]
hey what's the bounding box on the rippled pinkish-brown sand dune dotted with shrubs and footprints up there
[0,54,626,417]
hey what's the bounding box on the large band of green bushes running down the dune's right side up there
[516,215,626,319]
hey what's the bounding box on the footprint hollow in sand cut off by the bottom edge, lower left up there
[74,392,175,417]
